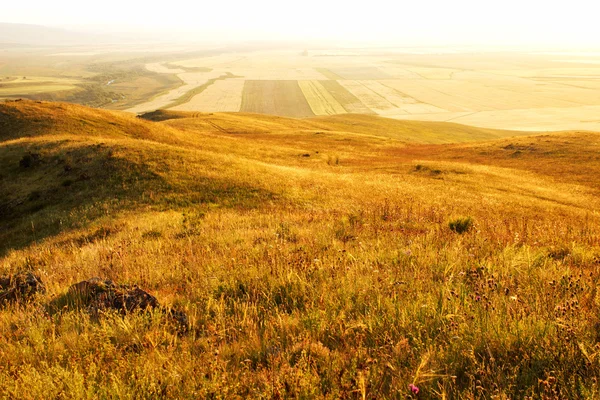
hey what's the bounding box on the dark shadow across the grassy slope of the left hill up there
[0,141,275,257]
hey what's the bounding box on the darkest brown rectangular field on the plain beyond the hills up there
[240,80,315,118]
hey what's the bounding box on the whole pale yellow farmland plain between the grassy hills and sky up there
[5,47,600,130]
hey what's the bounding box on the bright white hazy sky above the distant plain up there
[0,0,600,48]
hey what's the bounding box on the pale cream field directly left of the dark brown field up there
[172,79,245,112]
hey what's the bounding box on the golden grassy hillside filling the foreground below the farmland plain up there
[0,101,600,399]
